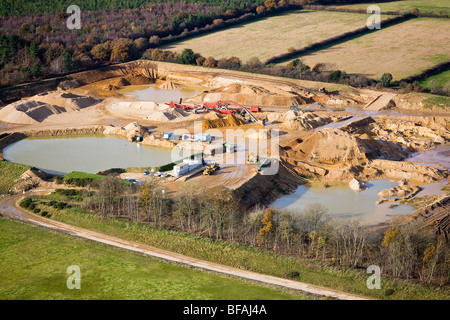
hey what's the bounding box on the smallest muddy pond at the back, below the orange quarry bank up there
[120,85,201,102]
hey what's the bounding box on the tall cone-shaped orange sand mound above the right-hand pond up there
[282,128,374,164]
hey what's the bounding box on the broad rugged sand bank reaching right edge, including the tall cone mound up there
[280,117,450,184]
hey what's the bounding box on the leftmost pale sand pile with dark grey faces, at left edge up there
[0,100,66,124]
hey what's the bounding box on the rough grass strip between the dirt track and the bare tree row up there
[24,196,450,299]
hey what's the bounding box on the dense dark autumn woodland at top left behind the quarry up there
[0,0,301,86]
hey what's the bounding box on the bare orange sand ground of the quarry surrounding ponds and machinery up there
[0,61,450,230]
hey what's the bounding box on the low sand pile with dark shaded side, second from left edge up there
[29,91,101,110]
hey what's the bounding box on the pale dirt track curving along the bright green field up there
[0,195,367,300]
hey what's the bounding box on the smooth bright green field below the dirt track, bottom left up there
[0,218,312,300]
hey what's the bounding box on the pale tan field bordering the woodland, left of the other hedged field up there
[162,10,368,62]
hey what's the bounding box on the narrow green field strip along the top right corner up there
[328,0,450,14]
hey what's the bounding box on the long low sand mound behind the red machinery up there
[186,83,309,106]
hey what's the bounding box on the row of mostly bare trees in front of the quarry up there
[74,177,450,286]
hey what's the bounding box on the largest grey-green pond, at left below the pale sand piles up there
[3,135,180,174]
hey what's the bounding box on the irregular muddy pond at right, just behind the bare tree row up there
[271,179,414,224]
